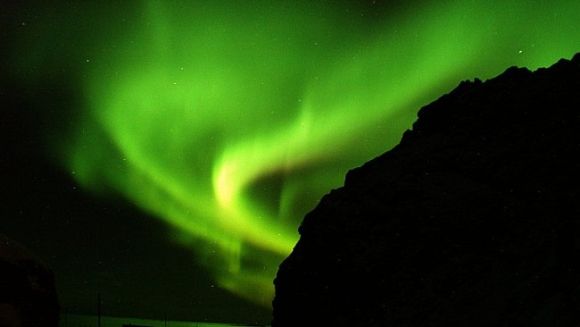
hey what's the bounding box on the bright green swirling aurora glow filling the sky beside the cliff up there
[12,0,580,306]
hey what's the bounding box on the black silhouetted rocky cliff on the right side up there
[273,54,580,327]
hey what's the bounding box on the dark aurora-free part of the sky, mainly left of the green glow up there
[0,1,416,323]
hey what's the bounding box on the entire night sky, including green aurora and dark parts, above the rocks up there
[0,0,580,323]
